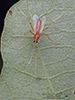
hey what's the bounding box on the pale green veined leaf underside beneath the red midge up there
[0,0,75,100]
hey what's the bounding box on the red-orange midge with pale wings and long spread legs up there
[16,8,63,43]
